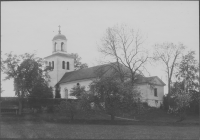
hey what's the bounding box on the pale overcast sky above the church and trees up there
[1,1,199,96]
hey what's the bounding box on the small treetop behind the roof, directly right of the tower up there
[70,53,88,70]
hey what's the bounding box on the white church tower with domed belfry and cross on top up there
[44,26,74,87]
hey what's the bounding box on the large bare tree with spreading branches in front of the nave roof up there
[99,25,149,85]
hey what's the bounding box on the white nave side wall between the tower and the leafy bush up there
[60,79,93,98]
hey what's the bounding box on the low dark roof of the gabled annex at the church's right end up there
[136,76,166,86]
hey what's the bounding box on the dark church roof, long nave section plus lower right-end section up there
[58,63,165,86]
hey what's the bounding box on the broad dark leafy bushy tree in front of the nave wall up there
[90,77,140,120]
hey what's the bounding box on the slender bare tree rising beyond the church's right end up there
[154,43,185,94]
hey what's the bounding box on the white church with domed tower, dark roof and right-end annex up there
[44,28,165,107]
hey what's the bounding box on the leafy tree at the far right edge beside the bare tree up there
[168,51,200,121]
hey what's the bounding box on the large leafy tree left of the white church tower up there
[2,53,52,114]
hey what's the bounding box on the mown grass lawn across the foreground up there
[0,114,200,140]
